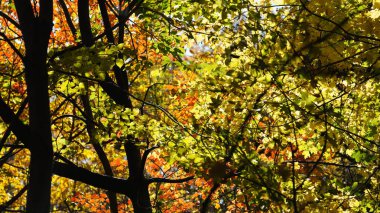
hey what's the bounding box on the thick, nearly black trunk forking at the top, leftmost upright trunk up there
[15,0,53,212]
